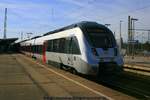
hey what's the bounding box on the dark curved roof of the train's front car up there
[43,21,106,36]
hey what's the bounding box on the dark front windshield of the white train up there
[87,29,115,48]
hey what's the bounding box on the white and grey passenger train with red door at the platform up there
[19,21,124,76]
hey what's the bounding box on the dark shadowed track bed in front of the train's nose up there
[84,72,150,100]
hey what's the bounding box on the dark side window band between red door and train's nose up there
[47,37,80,54]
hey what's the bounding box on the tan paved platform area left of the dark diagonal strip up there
[0,54,45,100]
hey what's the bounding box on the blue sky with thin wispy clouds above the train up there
[0,0,150,41]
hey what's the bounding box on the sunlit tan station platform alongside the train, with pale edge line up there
[0,54,135,100]
